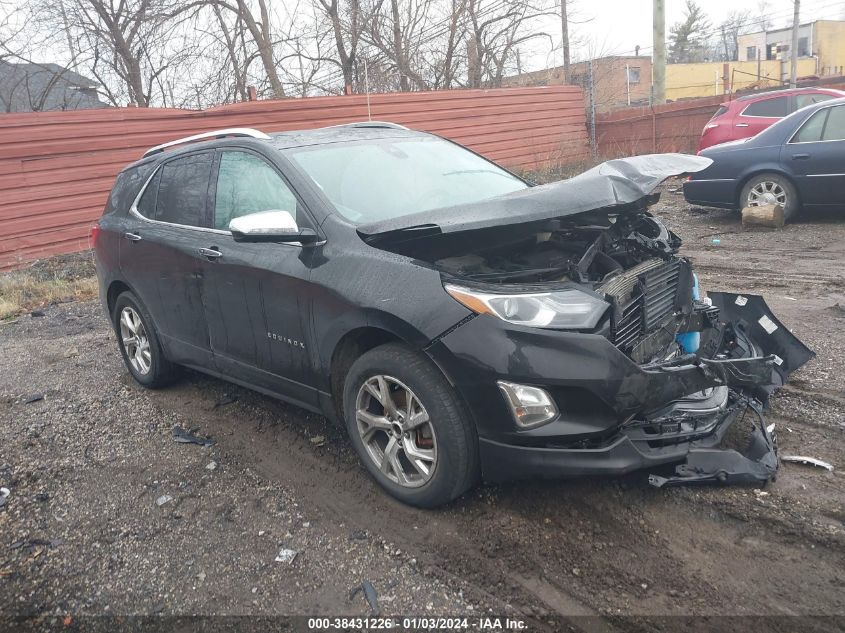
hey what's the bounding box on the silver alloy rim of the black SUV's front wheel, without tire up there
[355,375,437,488]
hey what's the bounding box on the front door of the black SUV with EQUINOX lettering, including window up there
[198,148,317,404]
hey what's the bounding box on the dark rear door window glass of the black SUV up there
[155,152,214,226]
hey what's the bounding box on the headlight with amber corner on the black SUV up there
[445,284,609,330]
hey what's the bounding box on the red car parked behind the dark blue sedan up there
[698,88,845,151]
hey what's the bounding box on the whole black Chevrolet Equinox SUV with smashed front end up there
[93,122,812,506]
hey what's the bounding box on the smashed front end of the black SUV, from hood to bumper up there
[359,155,814,487]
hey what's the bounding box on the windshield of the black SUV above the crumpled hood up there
[289,137,528,223]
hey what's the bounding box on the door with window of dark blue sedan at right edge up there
[781,106,845,205]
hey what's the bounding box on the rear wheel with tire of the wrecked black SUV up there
[112,291,178,389]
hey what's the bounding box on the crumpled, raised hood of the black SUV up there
[358,154,713,241]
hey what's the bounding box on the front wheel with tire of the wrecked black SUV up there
[343,343,479,508]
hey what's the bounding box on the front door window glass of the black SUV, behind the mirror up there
[214,151,302,231]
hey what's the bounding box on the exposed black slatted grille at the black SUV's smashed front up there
[613,259,681,353]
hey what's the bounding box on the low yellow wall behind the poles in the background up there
[666,58,816,101]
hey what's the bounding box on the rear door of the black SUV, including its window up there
[120,150,214,367]
